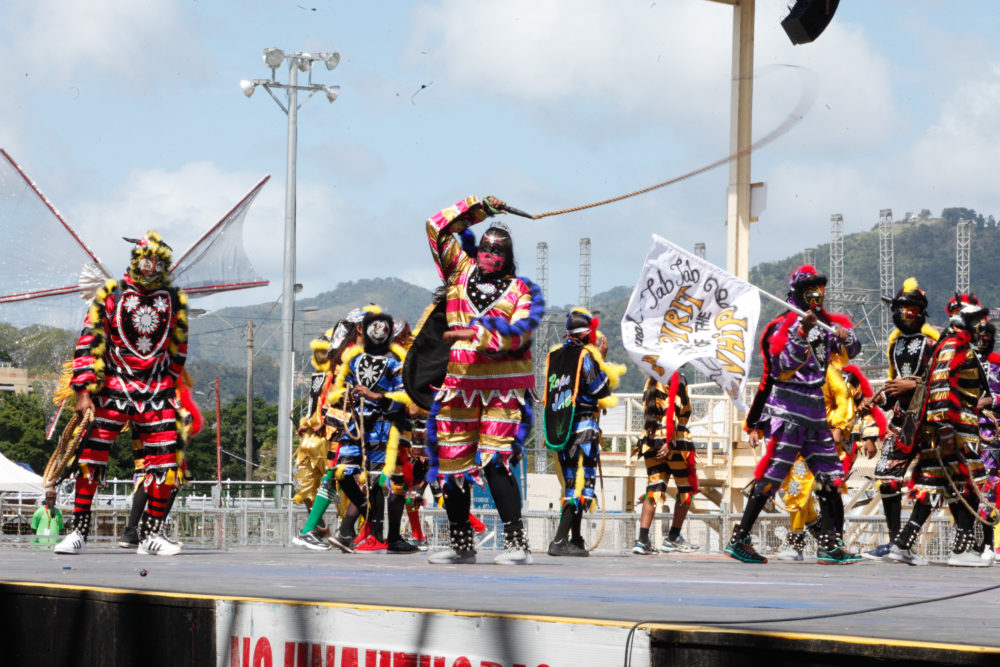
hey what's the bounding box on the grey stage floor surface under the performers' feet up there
[0,545,1000,653]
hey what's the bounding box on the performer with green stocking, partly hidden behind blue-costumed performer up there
[292,308,367,551]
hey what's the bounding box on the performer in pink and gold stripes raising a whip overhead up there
[426,197,545,565]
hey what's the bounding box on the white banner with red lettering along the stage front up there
[215,600,650,667]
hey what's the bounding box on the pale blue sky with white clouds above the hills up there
[0,0,1000,320]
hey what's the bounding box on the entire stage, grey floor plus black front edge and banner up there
[0,543,1000,667]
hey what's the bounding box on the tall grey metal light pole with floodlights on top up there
[240,47,340,484]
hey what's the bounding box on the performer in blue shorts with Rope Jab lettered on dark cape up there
[543,308,625,556]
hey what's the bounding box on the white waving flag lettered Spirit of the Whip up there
[622,234,760,411]
